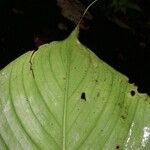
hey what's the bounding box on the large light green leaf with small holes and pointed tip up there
[0,29,150,150]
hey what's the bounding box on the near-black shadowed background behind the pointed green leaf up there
[0,0,150,95]
